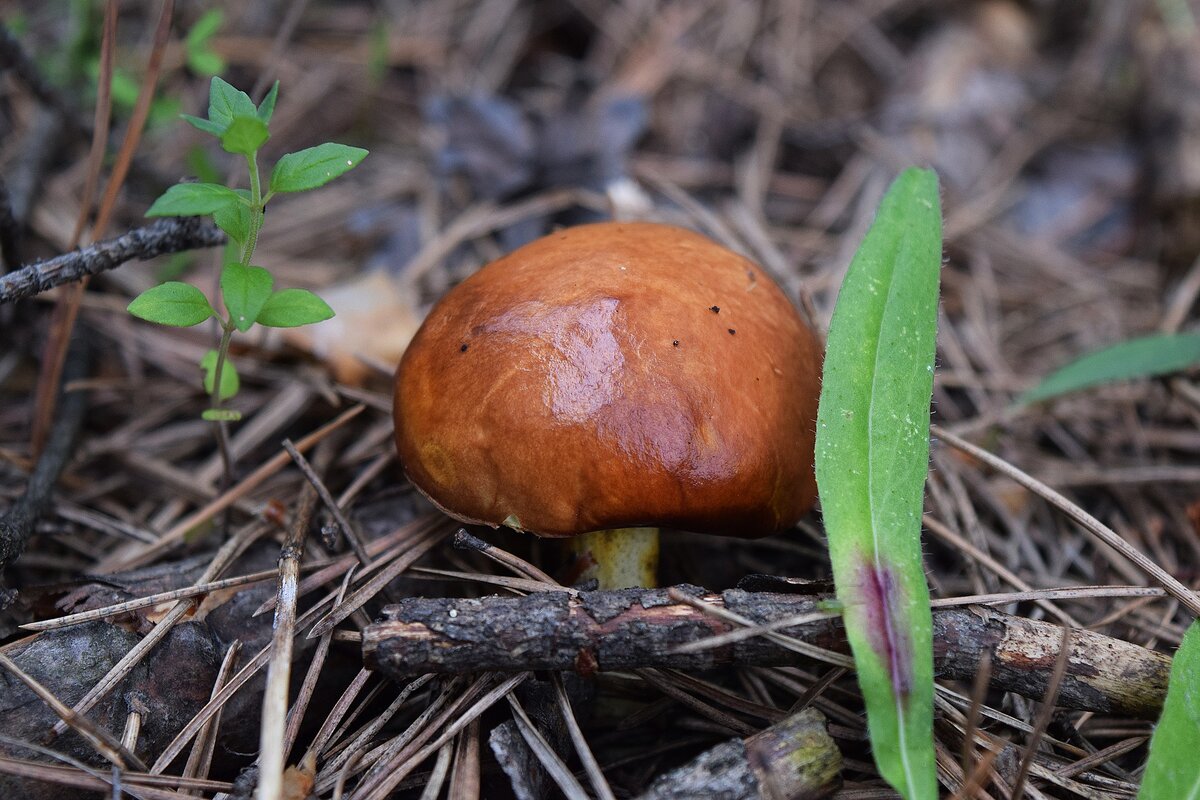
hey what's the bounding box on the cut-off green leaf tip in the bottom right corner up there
[1138,621,1200,800]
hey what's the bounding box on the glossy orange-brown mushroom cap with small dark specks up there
[395,222,821,536]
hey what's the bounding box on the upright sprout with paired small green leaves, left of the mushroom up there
[128,77,367,421]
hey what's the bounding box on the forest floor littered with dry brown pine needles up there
[0,0,1200,799]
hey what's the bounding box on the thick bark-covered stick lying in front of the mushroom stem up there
[362,587,1171,718]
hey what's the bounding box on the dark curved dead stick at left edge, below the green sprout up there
[0,335,89,570]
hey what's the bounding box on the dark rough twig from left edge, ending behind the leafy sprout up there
[0,217,226,303]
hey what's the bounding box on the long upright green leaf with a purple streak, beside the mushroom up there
[816,169,942,800]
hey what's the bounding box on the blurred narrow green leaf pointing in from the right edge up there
[1016,333,1200,405]
